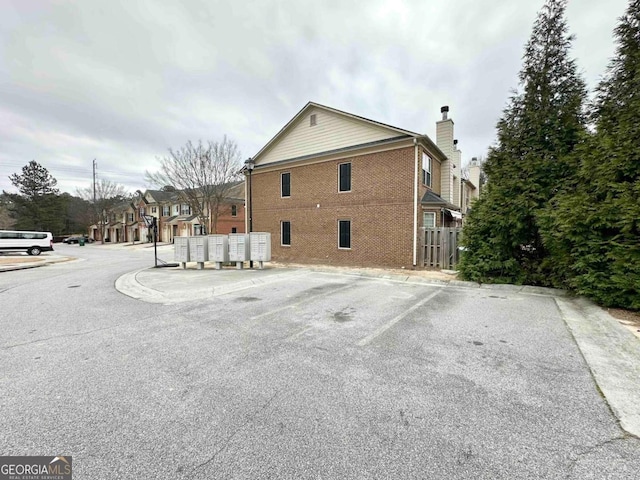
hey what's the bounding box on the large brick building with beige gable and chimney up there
[245,102,477,268]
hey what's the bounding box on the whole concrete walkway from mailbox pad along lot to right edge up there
[116,264,640,437]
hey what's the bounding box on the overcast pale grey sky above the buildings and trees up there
[0,0,627,193]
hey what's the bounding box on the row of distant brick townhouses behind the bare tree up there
[89,181,245,243]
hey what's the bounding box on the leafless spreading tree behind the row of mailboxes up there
[145,135,242,233]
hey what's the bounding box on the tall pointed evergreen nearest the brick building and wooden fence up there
[460,0,586,285]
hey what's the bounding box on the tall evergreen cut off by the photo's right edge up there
[545,0,640,310]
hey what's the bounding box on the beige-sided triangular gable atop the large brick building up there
[253,102,446,166]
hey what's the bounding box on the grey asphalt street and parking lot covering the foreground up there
[0,245,640,480]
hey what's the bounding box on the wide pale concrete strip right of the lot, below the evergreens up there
[555,297,640,437]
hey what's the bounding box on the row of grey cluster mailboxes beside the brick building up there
[173,232,271,270]
